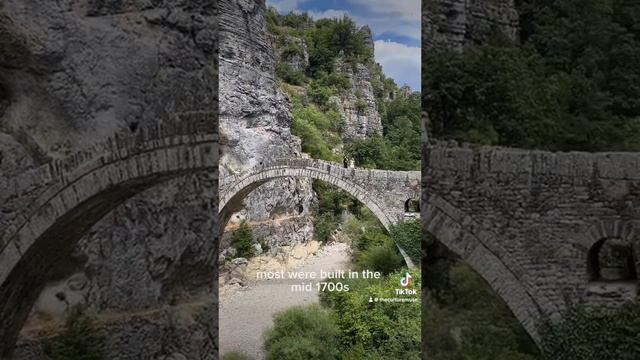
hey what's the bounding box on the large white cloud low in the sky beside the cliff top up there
[375,40,422,90]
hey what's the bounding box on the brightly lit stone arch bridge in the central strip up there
[218,158,420,267]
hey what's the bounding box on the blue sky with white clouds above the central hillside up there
[267,0,422,90]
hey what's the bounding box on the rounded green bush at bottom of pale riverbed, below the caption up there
[265,305,340,360]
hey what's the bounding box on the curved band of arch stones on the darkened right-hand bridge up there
[422,191,544,343]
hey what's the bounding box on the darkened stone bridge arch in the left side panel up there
[0,120,218,358]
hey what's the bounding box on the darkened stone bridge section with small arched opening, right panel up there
[421,144,640,342]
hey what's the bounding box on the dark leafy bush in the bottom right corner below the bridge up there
[542,302,640,360]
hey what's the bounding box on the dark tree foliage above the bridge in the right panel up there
[423,0,640,151]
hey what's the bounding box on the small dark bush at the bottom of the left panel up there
[45,308,106,360]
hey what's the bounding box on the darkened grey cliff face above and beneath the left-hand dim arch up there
[0,0,217,359]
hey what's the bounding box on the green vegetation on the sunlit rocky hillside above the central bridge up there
[267,8,421,170]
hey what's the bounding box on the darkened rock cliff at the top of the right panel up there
[422,0,518,50]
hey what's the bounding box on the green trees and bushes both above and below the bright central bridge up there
[265,9,421,360]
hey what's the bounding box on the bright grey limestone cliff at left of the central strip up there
[219,0,314,255]
